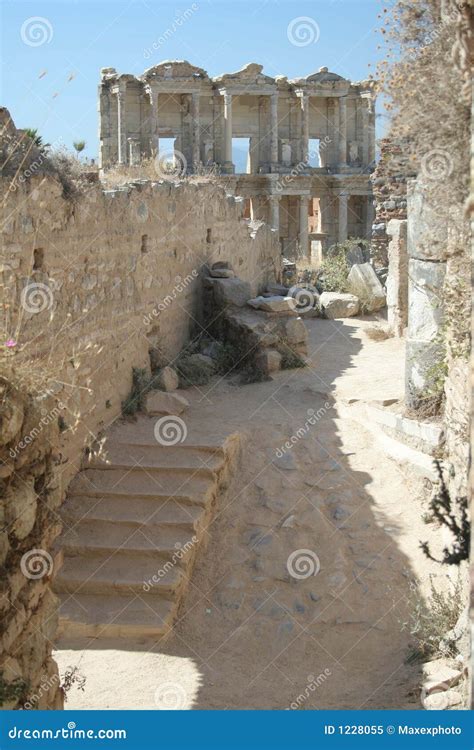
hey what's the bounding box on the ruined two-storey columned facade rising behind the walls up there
[99,61,375,260]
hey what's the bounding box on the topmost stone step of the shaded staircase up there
[84,442,225,477]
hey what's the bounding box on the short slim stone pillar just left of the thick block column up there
[386,219,408,337]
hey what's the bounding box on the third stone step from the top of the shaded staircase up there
[61,494,205,531]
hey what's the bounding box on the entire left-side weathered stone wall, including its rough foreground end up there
[0,170,280,708]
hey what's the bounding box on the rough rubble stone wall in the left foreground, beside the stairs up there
[0,378,63,709]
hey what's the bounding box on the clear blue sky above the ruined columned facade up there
[0,0,382,158]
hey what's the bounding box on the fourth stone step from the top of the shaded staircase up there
[61,520,197,566]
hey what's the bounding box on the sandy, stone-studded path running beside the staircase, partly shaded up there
[56,319,448,710]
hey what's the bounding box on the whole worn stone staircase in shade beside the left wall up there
[55,415,239,637]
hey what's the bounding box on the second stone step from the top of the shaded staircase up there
[69,467,215,499]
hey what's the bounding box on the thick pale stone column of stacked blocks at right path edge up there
[404,180,448,409]
